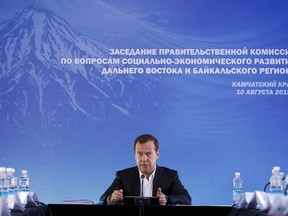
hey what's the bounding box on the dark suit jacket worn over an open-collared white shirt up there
[100,165,192,205]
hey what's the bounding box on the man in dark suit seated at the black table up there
[100,134,192,205]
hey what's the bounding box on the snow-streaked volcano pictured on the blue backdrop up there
[0,5,161,128]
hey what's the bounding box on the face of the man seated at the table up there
[135,141,160,176]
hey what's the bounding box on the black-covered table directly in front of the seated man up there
[47,204,232,216]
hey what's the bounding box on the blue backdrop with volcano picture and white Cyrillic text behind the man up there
[0,0,288,205]
